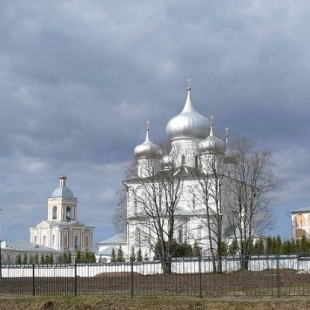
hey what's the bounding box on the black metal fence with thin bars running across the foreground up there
[0,255,310,298]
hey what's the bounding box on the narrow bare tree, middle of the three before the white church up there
[186,133,226,272]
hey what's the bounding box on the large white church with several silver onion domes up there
[124,87,234,259]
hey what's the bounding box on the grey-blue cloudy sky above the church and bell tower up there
[0,0,310,247]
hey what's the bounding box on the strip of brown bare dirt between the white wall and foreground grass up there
[0,269,310,298]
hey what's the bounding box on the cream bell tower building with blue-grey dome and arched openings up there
[29,175,94,260]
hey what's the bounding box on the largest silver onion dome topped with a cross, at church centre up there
[166,87,209,141]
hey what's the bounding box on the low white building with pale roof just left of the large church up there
[96,233,128,263]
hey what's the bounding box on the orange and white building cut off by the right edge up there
[291,207,310,240]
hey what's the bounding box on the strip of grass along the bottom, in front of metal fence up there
[0,295,310,310]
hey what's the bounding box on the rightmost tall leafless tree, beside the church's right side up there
[226,138,283,268]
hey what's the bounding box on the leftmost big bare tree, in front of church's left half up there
[124,149,184,273]
